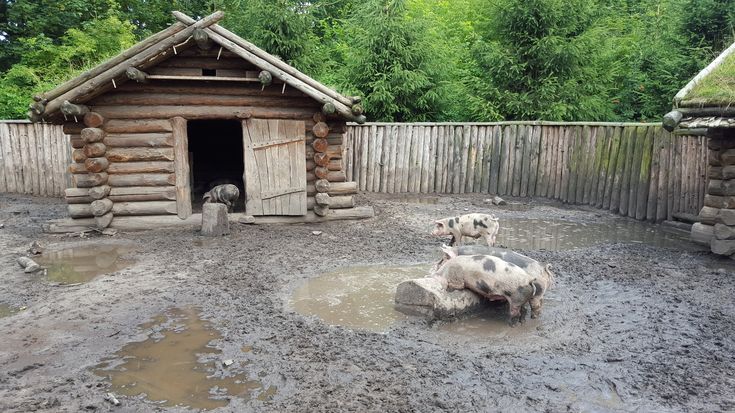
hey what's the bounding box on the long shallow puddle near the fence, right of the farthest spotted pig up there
[496,218,701,251]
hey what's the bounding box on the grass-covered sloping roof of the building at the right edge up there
[663,39,735,130]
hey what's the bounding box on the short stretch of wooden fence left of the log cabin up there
[0,120,71,196]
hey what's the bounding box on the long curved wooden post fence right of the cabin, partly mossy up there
[344,122,708,221]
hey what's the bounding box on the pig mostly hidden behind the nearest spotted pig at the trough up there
[431,245,554,318]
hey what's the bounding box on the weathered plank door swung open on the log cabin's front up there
[242,119,306,215]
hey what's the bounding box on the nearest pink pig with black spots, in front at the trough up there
[434,251,543,326]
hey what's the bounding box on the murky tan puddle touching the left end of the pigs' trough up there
[291,265,429,332]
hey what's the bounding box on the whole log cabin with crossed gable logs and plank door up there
[29,12,373,229]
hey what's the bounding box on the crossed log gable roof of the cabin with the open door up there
[29,11,365,123]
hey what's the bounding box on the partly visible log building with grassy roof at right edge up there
[663,38,735,254]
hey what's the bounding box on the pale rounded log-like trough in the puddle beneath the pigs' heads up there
[395,277,483,319]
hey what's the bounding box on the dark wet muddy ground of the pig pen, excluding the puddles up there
[0,195,735,412]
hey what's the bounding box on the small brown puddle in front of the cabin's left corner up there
[34,243,135,284]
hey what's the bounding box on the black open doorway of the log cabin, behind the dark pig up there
[187,120,245,212]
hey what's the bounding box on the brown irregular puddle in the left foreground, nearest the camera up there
[94,308,277,410]
